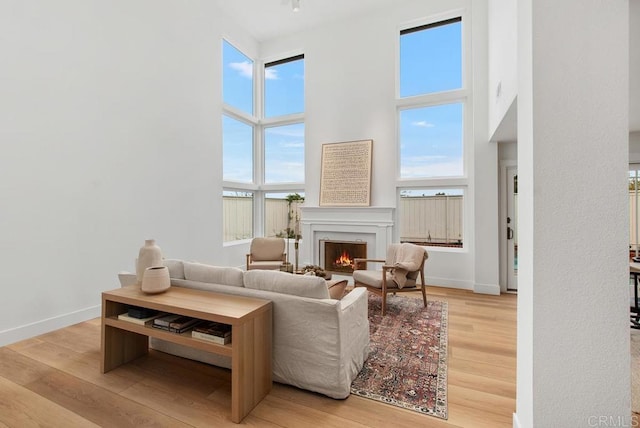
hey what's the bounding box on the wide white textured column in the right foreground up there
[514,0,631,428]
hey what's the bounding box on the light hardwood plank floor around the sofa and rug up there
[0,287,516,428]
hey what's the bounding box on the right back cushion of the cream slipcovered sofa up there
[244,270,331,299]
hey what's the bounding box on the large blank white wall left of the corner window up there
[0,0,257,345]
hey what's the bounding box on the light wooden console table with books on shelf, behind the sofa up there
[100,285,273,423]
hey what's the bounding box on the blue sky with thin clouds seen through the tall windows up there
[223,18,464,183]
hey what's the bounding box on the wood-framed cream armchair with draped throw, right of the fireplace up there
[353,243,429,315]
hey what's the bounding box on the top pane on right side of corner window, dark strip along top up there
[264,55,304,117]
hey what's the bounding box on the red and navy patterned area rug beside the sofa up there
[351,293,447,419]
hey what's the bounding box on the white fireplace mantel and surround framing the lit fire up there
[300,206,394,264]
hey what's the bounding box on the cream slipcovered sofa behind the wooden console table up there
[120,260,369,399]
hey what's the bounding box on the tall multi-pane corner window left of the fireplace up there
[222,41,304,242]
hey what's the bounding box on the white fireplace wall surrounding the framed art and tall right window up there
[261,0,490,290]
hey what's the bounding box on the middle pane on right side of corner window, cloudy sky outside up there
[264,123,304,183]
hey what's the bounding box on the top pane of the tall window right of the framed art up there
[400,17,462,97]
